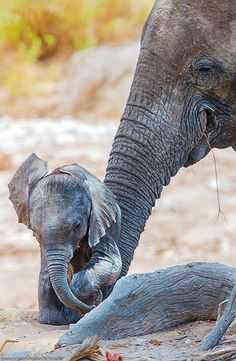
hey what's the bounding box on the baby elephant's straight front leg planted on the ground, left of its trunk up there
[38,248,81,325]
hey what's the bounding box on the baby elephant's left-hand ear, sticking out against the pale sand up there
[8,153,48,226]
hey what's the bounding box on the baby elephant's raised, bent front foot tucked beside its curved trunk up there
[70,270,103,306]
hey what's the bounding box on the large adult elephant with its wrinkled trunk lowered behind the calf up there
[105,0,236,276]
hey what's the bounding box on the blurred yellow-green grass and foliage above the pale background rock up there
[0,0,153,101]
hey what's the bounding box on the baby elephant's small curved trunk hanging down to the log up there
[45,247,94,313]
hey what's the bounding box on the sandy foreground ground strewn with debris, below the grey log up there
[0,311,236,361]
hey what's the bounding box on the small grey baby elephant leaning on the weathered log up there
[9,154,121,325]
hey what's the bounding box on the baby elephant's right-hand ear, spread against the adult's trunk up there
[60,164,119,247]
